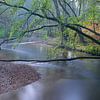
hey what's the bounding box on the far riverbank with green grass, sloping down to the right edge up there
[32,38,100,56]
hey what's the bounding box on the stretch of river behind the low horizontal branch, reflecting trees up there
[0,43,90,59]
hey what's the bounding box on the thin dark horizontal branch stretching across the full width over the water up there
[0,56,100,62]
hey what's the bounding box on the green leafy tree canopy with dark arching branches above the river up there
[0,0,100,45]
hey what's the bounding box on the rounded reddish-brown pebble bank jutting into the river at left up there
[0,62,39,94]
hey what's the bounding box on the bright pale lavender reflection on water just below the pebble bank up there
[18,82,43,100]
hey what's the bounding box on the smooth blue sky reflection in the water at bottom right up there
[43,79,100,100]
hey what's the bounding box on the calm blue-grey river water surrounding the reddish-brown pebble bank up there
[0,44,100,100]
